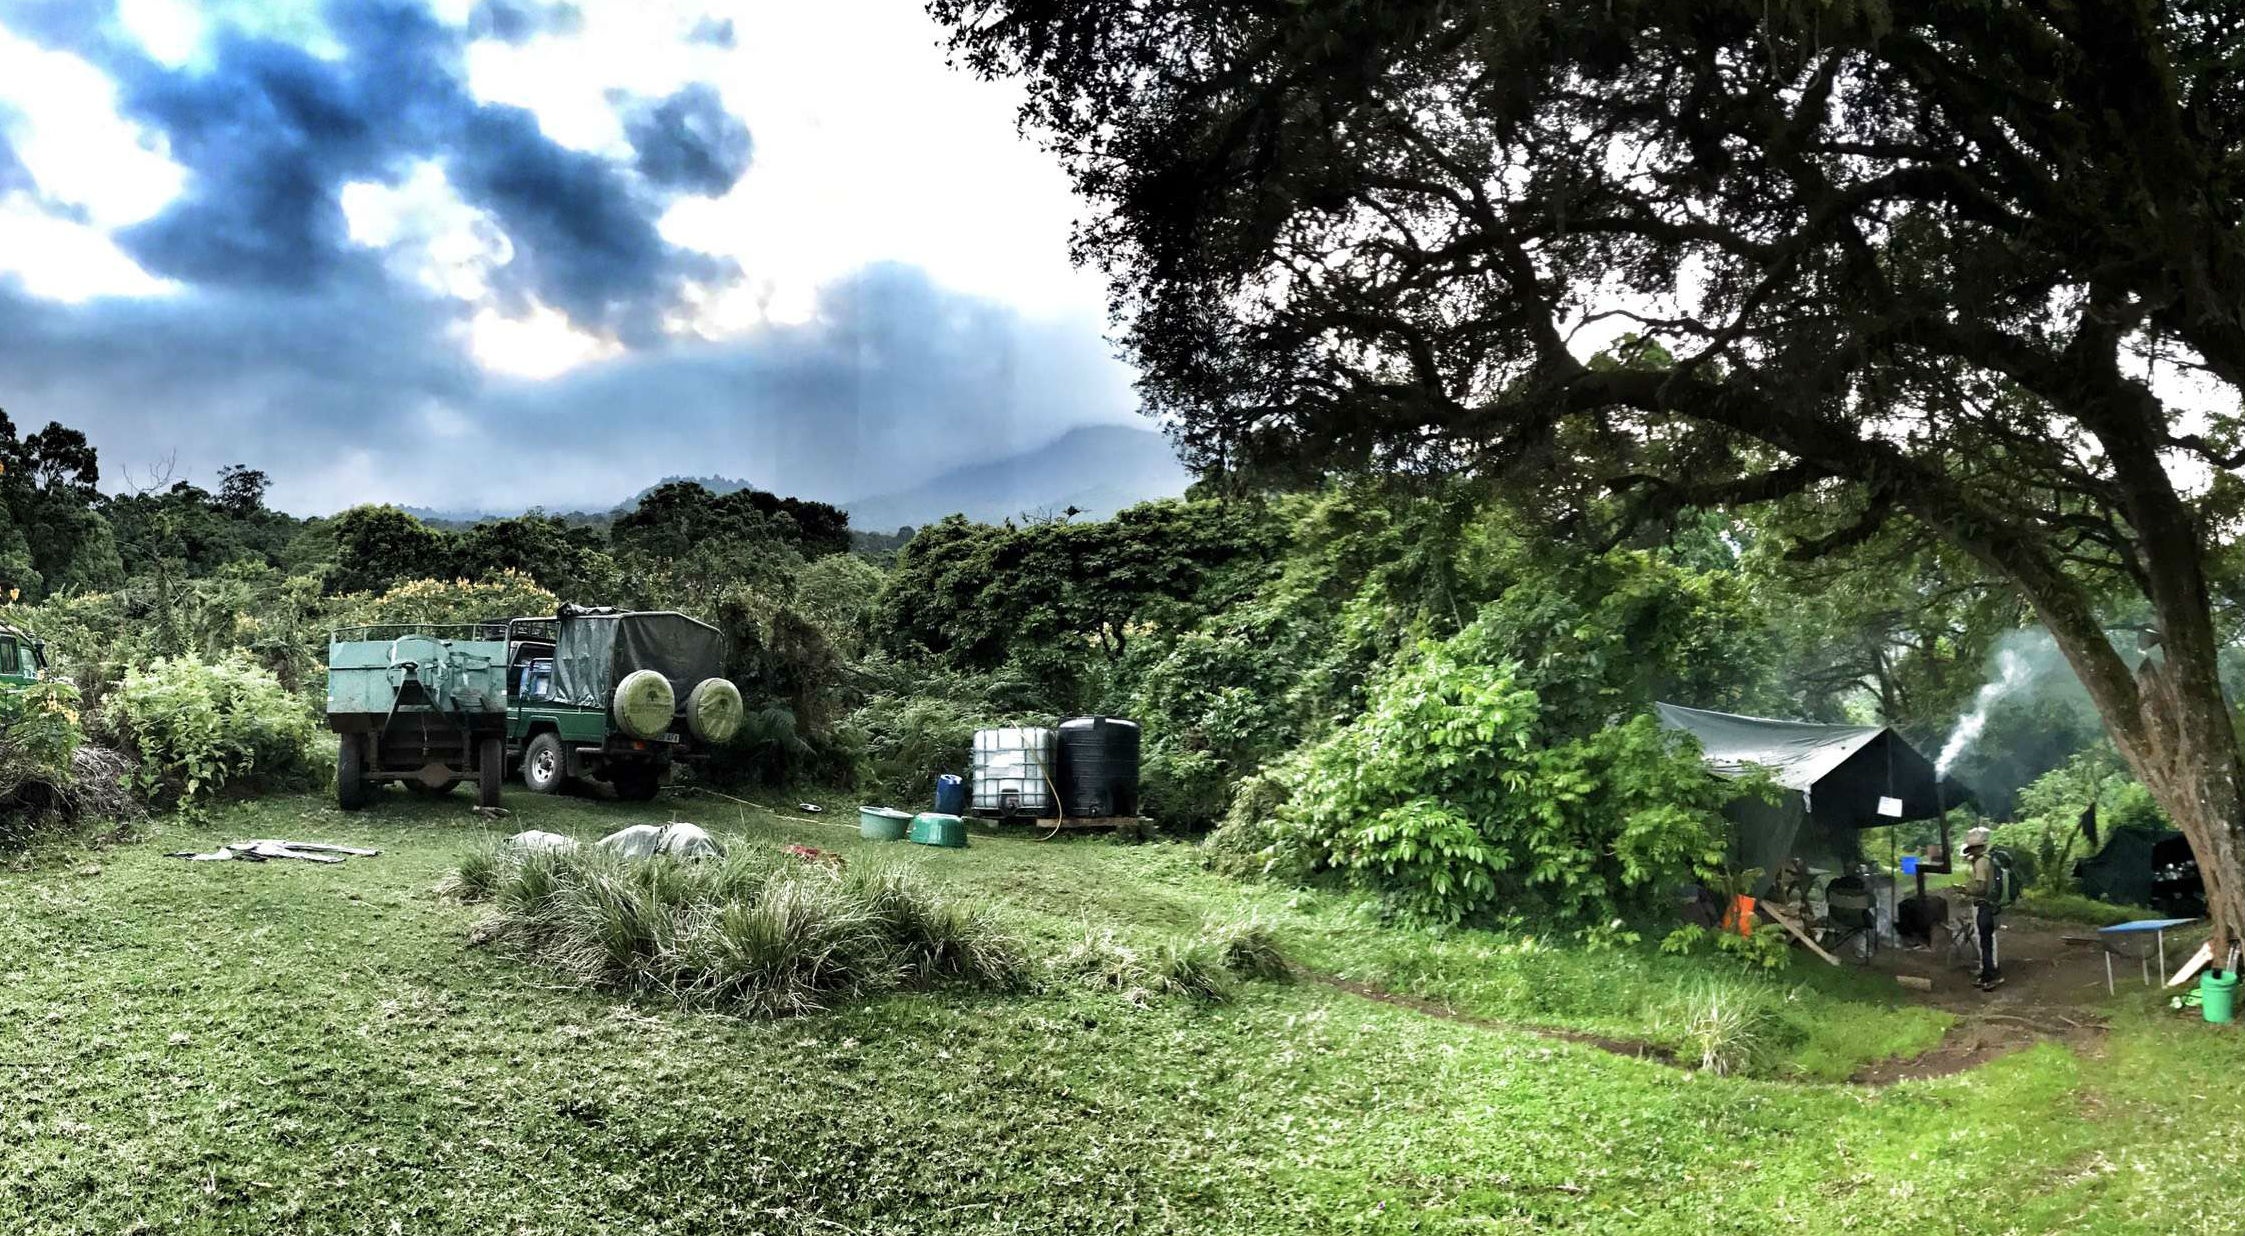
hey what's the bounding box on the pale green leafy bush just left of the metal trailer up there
[108,651,332,803]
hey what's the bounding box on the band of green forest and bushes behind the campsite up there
[0,410,2173,920]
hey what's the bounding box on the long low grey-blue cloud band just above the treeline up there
[0,267,1131,514]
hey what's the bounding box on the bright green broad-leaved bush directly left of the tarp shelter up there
[1273,624,1729,924]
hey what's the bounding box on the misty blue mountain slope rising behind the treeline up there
[842,424,1192,532]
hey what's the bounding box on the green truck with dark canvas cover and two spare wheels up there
[507,606,743,803]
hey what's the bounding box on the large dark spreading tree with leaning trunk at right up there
[932,0,2245,938]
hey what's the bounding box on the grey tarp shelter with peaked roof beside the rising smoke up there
[1655,704,1971,891]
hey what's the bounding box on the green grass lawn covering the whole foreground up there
[0,794,2245,1234]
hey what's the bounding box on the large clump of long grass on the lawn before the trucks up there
[460,843,1024,1016]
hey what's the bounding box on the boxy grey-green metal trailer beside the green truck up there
[328,624,507,810]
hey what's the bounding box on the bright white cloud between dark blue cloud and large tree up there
[469,0,1105,336]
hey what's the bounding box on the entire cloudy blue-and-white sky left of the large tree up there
[0,0,1145,514]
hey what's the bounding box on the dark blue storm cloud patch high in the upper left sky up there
[74,0,748,343]
